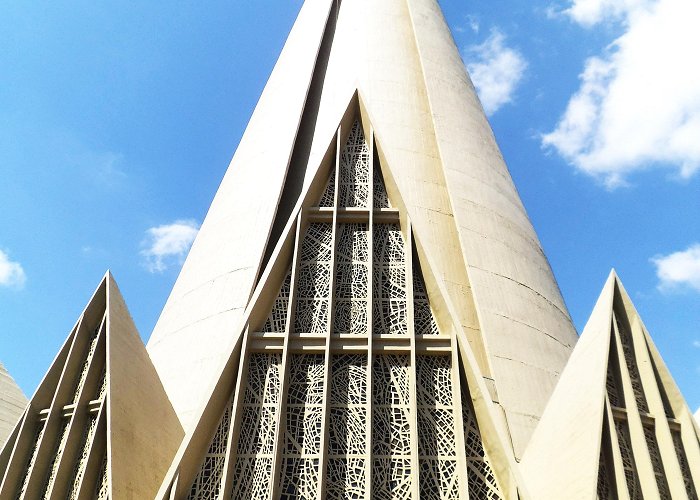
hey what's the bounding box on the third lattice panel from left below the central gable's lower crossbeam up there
[281,354,324,499]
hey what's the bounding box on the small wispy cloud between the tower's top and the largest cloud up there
[465,30,527,115]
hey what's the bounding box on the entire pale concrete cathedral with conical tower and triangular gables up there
[0,0,700,500]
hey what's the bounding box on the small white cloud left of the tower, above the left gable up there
[141,220,199,273]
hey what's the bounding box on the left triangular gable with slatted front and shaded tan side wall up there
[0,273,182,500]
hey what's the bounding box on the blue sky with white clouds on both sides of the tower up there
[0,0,700,422]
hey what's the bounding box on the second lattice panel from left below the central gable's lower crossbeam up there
[232,353,282,498]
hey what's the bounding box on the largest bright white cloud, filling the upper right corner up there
[542,0,700,187]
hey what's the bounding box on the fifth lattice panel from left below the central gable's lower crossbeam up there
[372,354,414,498]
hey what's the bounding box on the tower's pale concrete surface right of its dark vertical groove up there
[270,0,577,457]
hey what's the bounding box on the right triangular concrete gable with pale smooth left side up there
[521,271,700,499]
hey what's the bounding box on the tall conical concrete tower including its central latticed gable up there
[148,0,576,486]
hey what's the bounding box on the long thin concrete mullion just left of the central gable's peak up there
[317,127,341,500]
